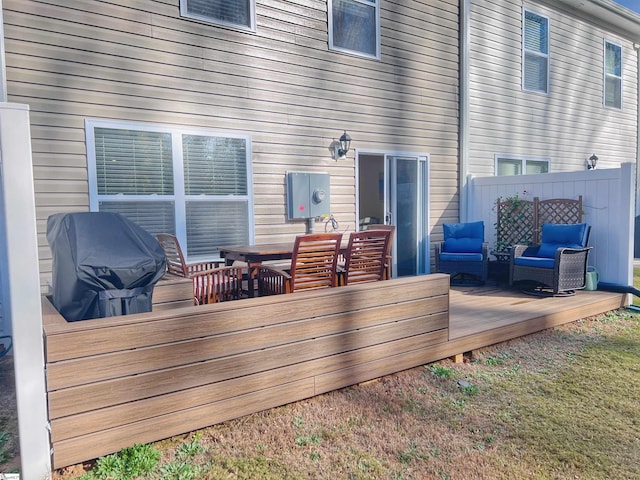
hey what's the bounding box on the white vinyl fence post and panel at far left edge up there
[0,103,51,480]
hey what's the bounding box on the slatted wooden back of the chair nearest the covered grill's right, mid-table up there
[291,233,342,292]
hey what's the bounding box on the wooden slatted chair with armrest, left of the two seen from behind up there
[258,233,342,296]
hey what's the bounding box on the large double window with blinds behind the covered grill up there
[86,120,253,259]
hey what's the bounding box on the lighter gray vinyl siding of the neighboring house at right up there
[469,0,638,175]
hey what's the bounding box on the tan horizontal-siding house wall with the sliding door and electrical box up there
[3,0,458,287]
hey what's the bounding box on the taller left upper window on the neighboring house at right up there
[522,10,549,93]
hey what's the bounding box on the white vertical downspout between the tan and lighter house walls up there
[458,0,471,222]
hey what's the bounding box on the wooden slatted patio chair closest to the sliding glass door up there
[339,228,392,285]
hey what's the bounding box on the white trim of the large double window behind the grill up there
[85,119,255,260]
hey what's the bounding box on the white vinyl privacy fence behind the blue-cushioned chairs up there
[467,163,636,285]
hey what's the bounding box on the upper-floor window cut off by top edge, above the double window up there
[180,0,256,31]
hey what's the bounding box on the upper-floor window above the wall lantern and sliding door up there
[329,0,380,58]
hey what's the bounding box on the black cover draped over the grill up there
[47,212,166,322]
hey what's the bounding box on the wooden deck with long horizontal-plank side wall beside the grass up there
[42,274,625,468]
